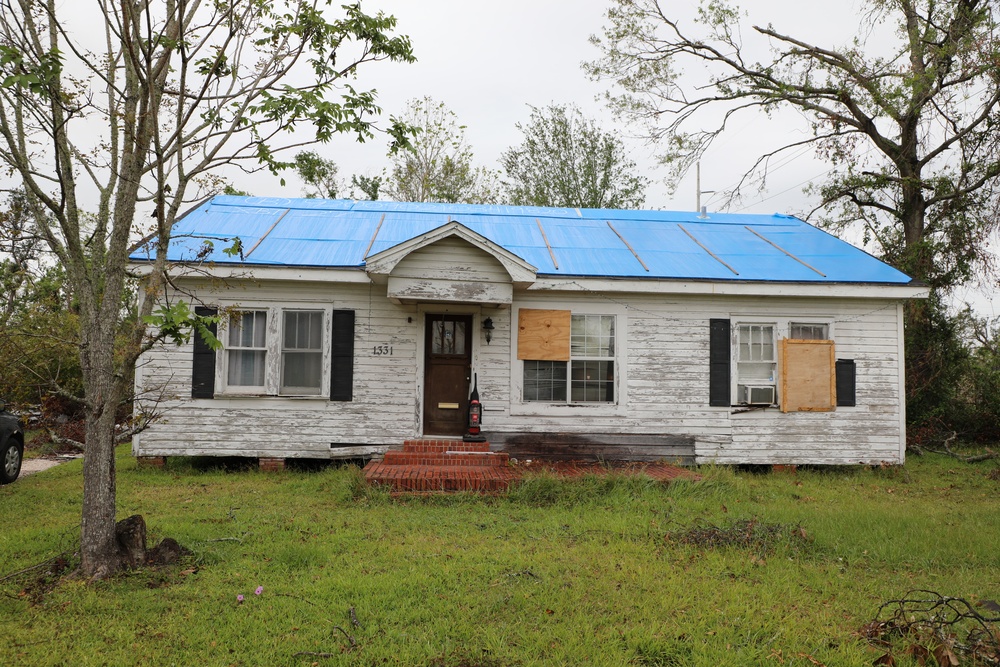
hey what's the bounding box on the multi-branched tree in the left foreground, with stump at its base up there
[0,0,413,578]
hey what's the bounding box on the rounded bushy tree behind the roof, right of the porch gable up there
[500,104,649,208]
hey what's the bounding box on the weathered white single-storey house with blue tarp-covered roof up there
[132,196,927,464]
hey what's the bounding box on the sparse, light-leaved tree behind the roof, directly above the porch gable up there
[380,97,496,203]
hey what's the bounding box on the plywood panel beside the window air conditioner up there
[779,338,837,412]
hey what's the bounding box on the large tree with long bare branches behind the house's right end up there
[587,0,1000,288]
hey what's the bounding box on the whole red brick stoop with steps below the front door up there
[364,439,517,493]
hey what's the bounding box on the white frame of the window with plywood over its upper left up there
[510,302,628,417]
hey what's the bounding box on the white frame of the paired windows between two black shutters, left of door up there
[215,301,333,400]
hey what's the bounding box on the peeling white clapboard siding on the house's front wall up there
[134,272,903,464]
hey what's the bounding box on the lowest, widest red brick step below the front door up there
[364,461,516,493]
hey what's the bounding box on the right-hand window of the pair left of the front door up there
[281,310,323,394]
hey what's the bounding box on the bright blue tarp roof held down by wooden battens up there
[132,196,911,284]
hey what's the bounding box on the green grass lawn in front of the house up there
[0,446,1000,667]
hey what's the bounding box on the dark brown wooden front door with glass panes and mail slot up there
[424,315,472,435]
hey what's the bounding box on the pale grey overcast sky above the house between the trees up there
[280,0,850,213]
